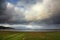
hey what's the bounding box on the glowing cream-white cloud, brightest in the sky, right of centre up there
[25,3,50,21]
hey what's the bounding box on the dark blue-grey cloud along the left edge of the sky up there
[0,0,9,23]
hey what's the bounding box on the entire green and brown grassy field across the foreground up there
[0,31,60,40]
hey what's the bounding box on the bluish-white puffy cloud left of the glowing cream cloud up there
[6,2,24,21]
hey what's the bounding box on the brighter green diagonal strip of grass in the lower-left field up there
[4,33,24,40]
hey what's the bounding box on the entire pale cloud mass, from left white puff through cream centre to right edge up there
[7,0,60,24]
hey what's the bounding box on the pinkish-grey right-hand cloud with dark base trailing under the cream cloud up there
[31,0,60,25]
